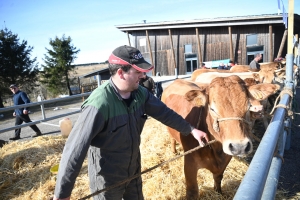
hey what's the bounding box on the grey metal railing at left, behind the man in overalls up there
[0,92,91,133]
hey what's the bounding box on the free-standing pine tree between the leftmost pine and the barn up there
[41,35,80,95]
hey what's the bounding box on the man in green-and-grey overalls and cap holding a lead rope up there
[54,46,208,200]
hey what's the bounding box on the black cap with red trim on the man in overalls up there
[108,45,154,72]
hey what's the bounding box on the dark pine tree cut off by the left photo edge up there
[0,28,39,106]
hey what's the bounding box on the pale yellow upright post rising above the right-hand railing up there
[287,0,294,54]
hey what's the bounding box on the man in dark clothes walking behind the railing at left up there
[9,84,42,140]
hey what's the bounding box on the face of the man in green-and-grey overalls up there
[123,67,144,92]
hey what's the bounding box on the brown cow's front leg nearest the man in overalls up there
[184,154,199,200]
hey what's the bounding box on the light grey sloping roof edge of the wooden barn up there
[116,14,300,32]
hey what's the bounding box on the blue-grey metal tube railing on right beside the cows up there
[234,54,294,200]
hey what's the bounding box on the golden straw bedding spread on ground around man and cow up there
[0,119,283,200]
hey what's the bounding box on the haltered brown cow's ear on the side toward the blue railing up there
[248,83,280,100]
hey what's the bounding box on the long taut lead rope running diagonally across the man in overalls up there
[79,140,216,200]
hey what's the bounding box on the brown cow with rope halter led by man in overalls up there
[162,76,275,199]
